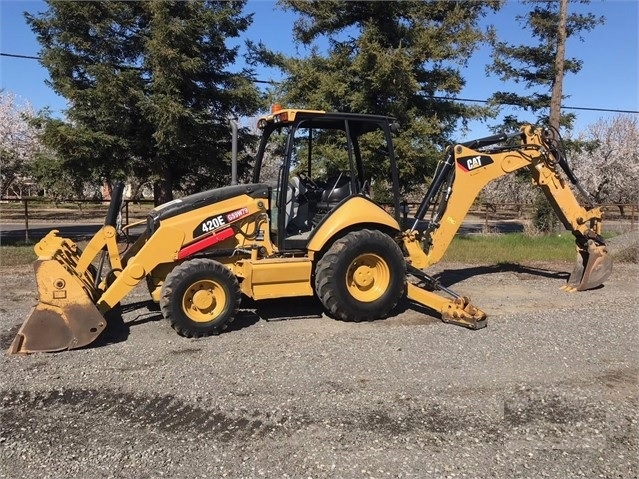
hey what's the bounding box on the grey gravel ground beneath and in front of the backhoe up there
[0,239,639,478]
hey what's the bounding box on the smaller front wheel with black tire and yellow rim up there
[160,259,241,338]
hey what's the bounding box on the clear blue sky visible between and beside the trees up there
[0,0,639,138]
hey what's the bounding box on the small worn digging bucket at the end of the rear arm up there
[562,240,612,291]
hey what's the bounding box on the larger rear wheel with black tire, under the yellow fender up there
[315,230,406,321]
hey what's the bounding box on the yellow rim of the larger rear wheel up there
[346,253,390,303]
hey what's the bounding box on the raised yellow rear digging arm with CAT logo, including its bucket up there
[403,126,612,290]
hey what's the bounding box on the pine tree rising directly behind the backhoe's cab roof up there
[254,0,497,193]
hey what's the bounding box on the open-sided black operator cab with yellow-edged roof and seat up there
[253,107,399,251]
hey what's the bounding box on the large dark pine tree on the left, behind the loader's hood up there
[27,0,260,202]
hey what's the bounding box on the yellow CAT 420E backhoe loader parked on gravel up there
[8,109,612,354]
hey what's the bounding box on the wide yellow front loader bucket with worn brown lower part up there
[7,242,106,354]
